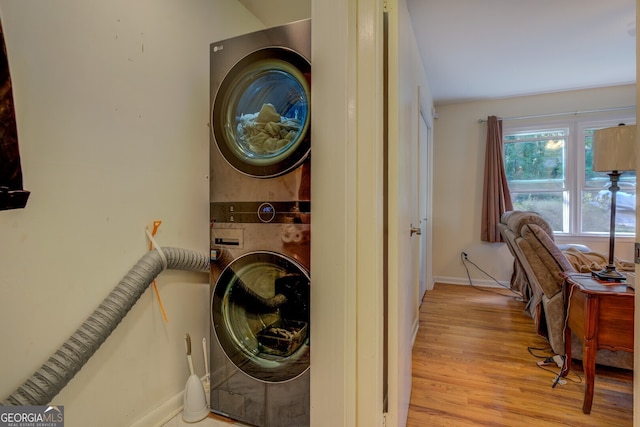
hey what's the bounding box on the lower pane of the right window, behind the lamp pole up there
[582,188,636,234]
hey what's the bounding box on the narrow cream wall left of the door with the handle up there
[387,0,432,426]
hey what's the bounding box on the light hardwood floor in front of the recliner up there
[407,284,633,427]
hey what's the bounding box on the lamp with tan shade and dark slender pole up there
[593,125,636,282]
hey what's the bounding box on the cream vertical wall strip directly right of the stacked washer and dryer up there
[311,0,357,427]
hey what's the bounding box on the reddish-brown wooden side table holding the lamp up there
[563,275,634,414]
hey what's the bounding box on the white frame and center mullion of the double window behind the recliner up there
[502,112,638,238]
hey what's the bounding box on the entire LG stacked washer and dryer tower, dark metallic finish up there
[210,20,311,427]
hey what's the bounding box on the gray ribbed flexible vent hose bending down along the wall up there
[0,248,210,406]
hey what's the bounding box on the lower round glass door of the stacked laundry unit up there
[211,251,310,382]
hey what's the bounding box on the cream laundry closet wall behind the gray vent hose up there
[0,0,264,427]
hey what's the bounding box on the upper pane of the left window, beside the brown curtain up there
[504,130,566,191]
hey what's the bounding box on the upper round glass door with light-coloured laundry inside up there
[211,48,311,178]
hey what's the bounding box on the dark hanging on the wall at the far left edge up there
[0,17,29,210]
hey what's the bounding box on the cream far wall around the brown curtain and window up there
[433,85,636,284]
